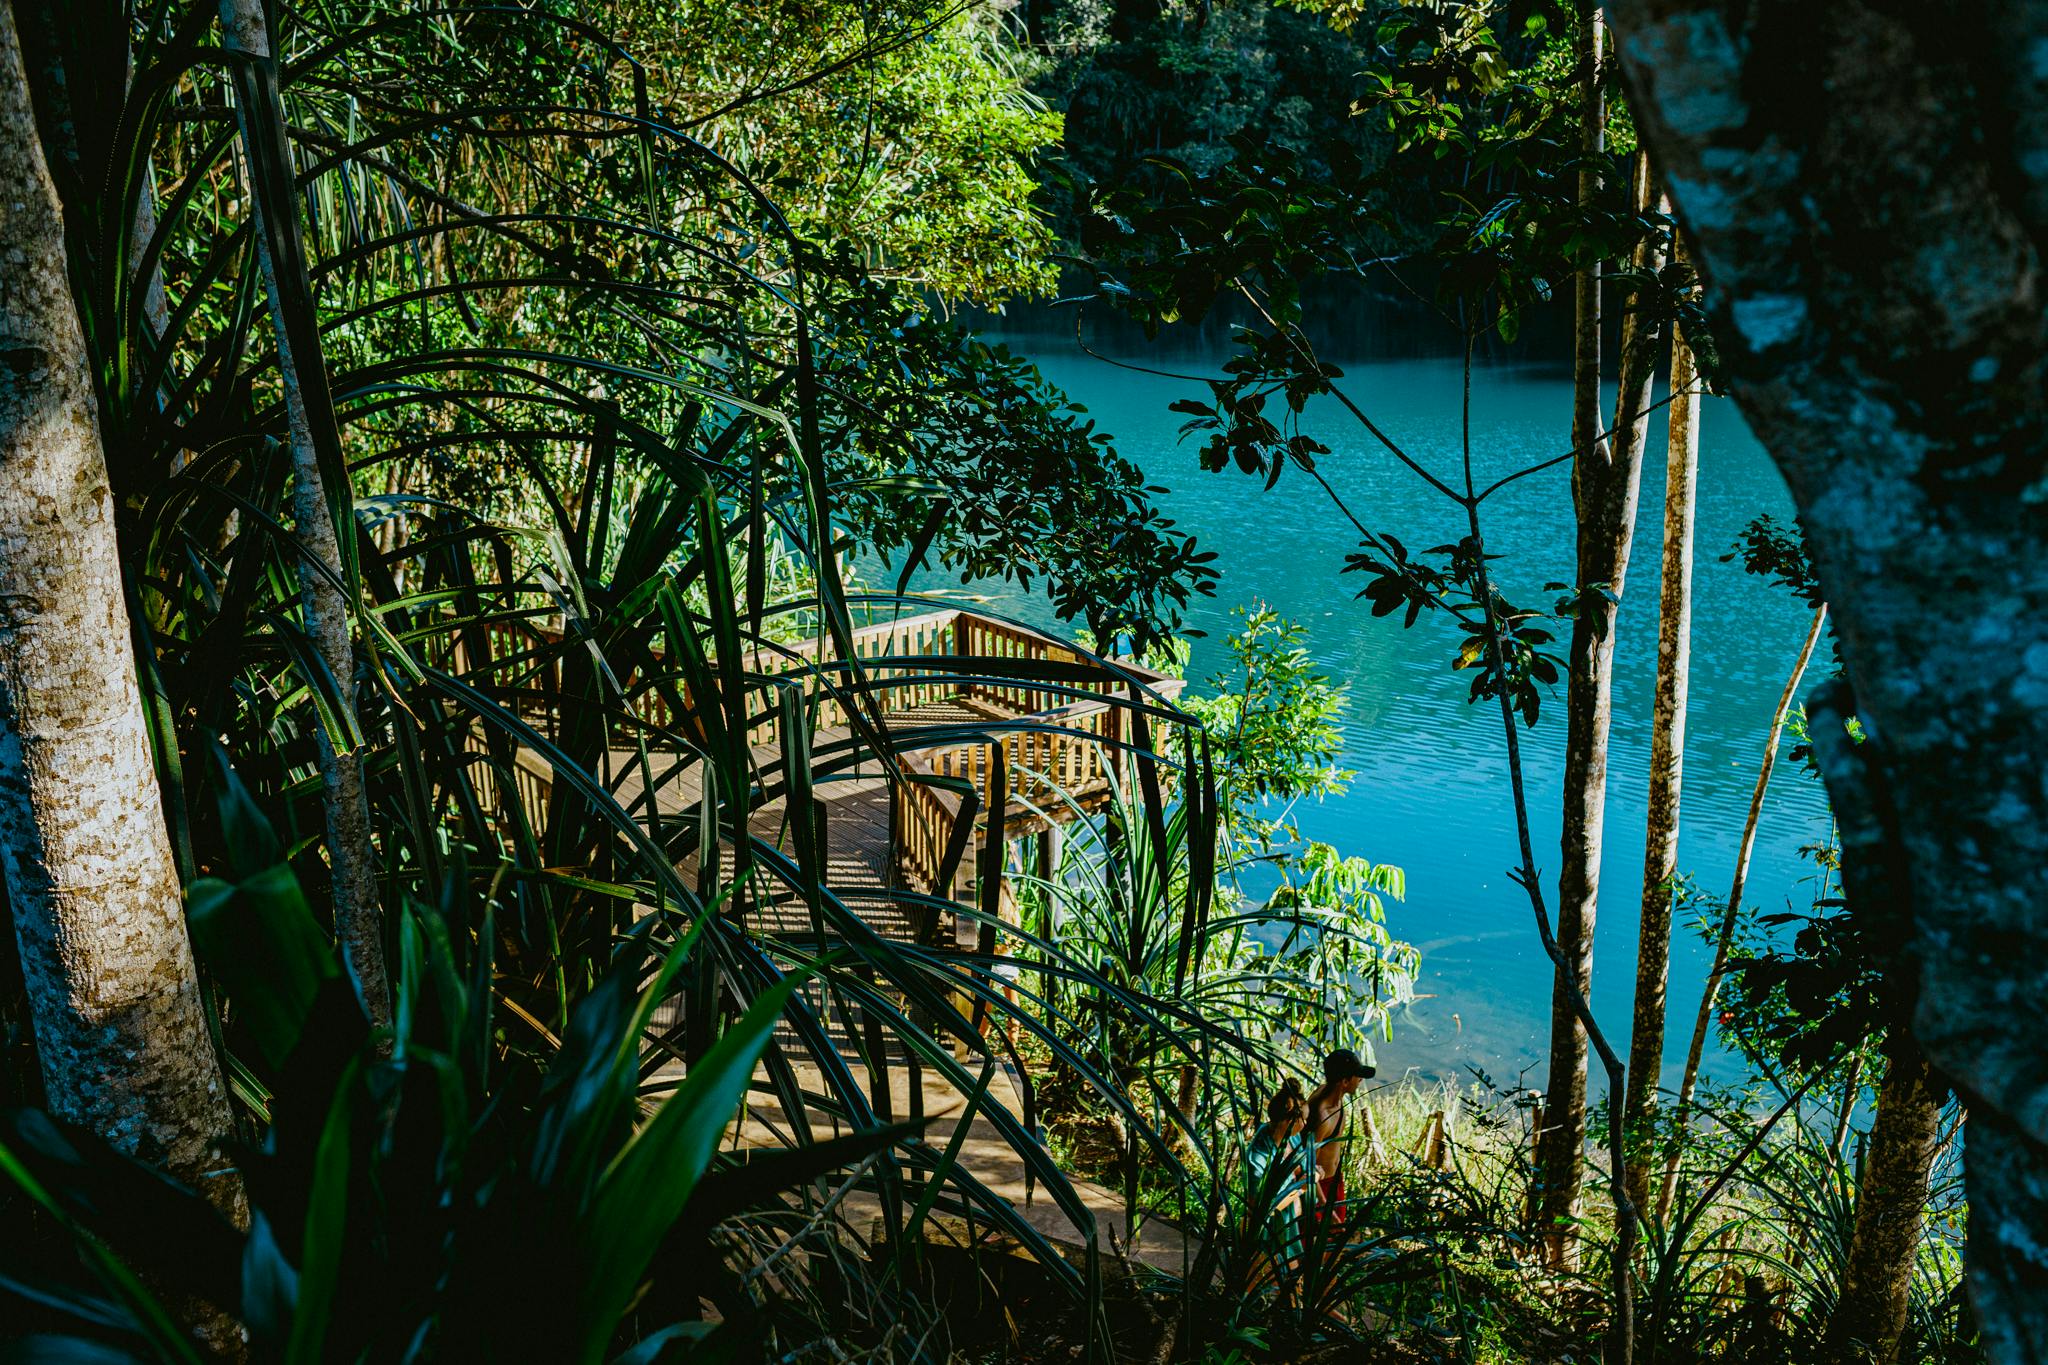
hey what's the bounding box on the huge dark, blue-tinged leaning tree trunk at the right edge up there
[1616,0,2048,1361]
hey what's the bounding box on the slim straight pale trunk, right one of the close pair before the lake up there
[1622,278,1700,1209]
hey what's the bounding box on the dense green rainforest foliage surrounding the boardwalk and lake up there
[0,0,1974,1365]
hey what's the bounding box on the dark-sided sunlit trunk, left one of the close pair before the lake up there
[1538,139,1663,1263]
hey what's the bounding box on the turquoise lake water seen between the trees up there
[922,321,1827,1085]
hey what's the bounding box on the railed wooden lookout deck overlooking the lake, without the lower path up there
[518,612,1182,945]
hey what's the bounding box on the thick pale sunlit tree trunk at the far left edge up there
[0,4,229,1179]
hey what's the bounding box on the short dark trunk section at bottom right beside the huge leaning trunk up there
[1827,1036,1942,1365]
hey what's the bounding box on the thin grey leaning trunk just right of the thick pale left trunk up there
[221,0,391,1027]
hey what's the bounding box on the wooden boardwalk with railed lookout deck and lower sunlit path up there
[499,612,1188,1271]
